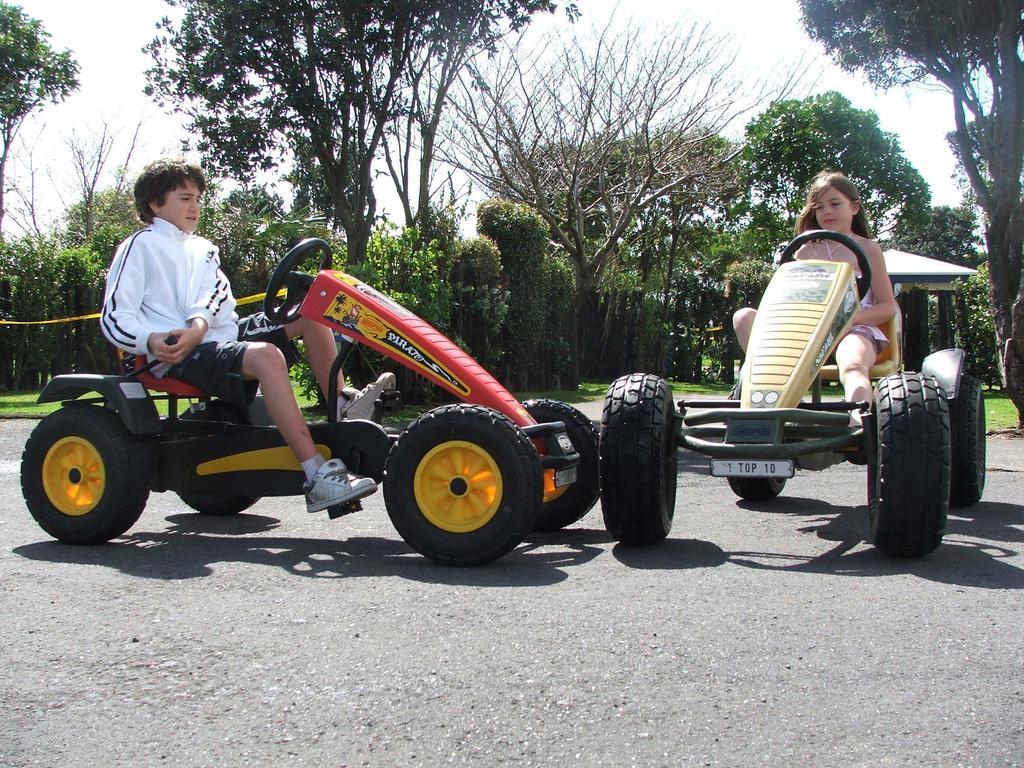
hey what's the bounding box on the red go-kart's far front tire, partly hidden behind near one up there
[522,399,601,531]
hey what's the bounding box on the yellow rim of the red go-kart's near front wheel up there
[413,440,503,534]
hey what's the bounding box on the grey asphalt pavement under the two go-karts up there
[0,407,1024,768]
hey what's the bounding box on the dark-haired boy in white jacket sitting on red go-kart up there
[100,159,394,512]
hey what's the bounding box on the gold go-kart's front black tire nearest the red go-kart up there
[599,374,679,546]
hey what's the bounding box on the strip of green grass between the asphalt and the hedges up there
[0,381,1017,430]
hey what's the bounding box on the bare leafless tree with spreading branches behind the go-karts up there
[447,18,770,372]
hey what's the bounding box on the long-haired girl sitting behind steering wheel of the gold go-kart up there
[732,171,897,426]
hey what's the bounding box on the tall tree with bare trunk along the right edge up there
[800,0,1024,427]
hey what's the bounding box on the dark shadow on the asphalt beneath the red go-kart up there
[13,514,606,587]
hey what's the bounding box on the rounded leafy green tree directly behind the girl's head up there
[741,91,930,244]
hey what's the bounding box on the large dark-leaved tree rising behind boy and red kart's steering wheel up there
[147,0,569,262]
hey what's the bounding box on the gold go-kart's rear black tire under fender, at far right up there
[947,375,986,507]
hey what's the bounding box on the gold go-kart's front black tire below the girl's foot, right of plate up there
[868,373,950,558]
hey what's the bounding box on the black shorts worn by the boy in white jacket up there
[166,312,299,406]
